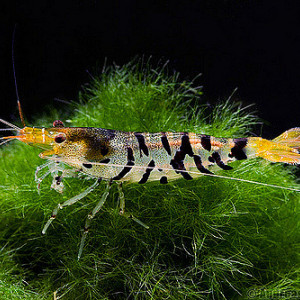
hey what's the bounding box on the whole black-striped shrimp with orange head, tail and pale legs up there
[0,119,300,258]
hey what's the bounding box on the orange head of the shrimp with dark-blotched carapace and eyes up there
[0,119,113,161]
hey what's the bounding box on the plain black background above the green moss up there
[0,0,300,137]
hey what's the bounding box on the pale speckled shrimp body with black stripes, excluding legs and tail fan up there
[32,127,255,183]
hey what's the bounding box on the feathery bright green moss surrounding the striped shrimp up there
[0,60,300,299]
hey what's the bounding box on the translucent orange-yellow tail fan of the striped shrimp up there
[249,127,300,165]
